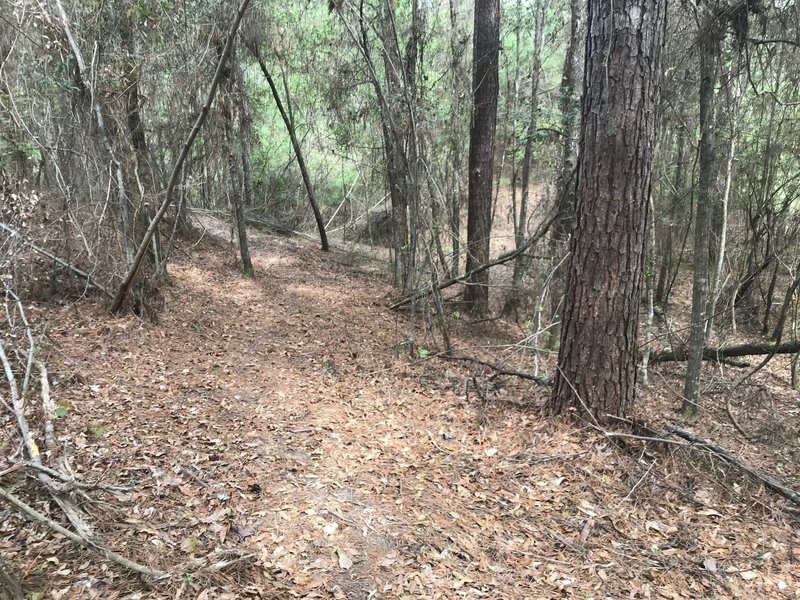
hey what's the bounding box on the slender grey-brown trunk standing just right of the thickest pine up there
[682,28,720,416]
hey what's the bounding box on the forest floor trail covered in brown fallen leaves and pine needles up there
[0,219,800,600]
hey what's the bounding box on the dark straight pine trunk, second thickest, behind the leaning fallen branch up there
[464,0,500,314]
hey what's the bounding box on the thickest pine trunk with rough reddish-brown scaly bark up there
[549,0,666,422]
